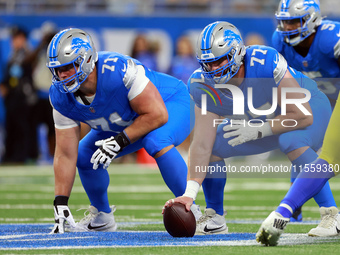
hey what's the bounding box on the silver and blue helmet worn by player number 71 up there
[46,28,98,93]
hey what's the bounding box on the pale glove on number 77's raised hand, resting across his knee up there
[223,120,273,147]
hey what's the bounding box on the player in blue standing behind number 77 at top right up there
[272,0,340,227]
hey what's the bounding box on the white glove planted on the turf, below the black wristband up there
[50,205,76,234]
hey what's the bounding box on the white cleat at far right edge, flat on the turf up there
[308,206,340,236]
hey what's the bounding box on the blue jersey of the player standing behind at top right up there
[272,20,340,101]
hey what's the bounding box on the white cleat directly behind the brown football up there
[195,208,228,235]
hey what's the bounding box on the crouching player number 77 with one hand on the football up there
[165,21,337,234]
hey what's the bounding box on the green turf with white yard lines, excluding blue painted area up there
[0,162,340,254]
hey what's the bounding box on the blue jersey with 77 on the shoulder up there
[189,46,321,121]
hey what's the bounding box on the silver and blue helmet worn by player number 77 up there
[196,21,246,83]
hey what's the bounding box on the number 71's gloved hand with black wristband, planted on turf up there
[50,196,76,234]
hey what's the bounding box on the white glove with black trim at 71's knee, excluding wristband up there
[91,136,123,170]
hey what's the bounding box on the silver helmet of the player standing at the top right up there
[275,0,322,46]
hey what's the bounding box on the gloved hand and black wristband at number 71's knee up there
[91,132,130,170]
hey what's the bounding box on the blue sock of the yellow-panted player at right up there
[276,158,334,218]
